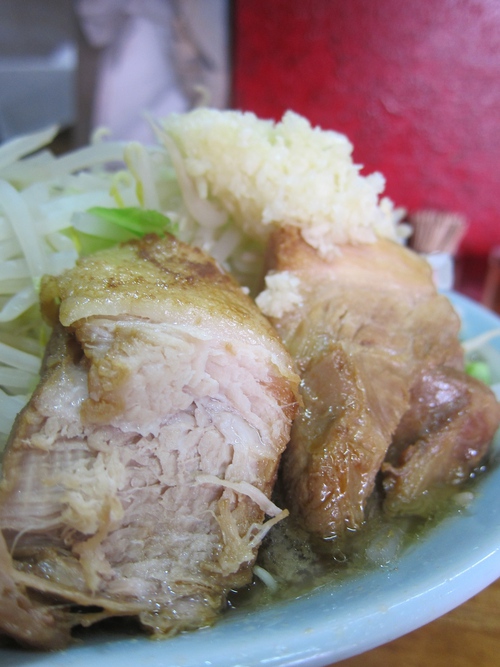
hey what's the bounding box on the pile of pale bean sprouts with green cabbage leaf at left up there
[0,128,183,449]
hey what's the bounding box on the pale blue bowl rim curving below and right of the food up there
[0,294,500,667]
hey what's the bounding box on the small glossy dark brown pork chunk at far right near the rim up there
[382,366,500,516]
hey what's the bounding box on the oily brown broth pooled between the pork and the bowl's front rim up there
[228,462,494,610]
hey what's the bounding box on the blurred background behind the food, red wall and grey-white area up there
[0,0,500,304]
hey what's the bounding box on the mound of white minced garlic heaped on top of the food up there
[163,108,399,255]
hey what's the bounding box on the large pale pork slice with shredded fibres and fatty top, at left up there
[0,237,298,648]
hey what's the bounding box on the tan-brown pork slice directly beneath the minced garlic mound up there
[268,228,488,538]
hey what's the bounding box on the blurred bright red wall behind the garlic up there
[233,0,500,255]
